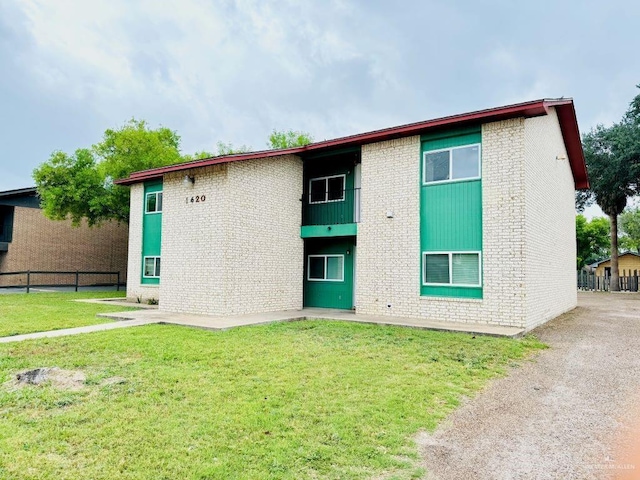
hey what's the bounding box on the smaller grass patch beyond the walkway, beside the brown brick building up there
[0,292,127,337]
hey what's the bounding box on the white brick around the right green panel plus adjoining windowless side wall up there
[356,115,576,328]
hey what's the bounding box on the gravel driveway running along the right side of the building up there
[417,293,640,480]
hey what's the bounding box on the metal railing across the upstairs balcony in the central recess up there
[302,188,360,225]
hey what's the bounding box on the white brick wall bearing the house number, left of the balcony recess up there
[158,156,303,315]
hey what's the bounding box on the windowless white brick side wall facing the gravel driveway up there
[524,109,578,329]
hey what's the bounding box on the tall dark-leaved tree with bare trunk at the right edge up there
[576,88,640,291]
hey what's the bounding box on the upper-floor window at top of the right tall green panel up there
[423,143,480,183]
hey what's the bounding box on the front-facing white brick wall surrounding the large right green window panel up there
[356,119,526,327]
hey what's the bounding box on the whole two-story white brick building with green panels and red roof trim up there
[119,99,588,329]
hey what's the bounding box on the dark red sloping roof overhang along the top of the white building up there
[115,99,589,189]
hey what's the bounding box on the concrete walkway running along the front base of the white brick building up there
[0,299,523,343]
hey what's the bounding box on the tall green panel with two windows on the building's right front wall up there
[420,126,482,298]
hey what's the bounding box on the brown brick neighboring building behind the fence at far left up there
[0,188,128,286]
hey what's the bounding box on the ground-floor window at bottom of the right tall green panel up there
[422,252,481,287]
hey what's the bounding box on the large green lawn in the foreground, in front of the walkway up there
[0,320,543,480]
